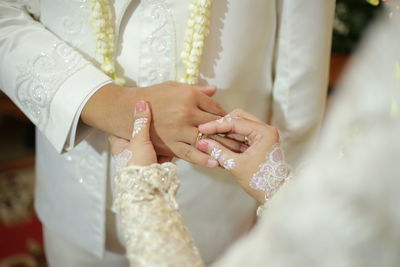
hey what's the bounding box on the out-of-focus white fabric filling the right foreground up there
[213,9,400,267]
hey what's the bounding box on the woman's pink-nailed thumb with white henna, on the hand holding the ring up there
[196,139,238,171]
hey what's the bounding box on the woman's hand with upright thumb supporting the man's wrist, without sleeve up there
[109,101,159,170]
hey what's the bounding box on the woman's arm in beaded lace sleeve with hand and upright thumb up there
[110,101,203,267]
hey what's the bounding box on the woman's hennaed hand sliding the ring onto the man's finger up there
[196,110,289,203]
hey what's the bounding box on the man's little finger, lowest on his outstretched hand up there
[171,142,218,168]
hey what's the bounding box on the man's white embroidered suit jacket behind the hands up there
[0,0,334,262]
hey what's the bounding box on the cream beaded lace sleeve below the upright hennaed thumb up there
[114,163,203,266]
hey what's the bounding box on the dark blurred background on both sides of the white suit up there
[0,0,382,267]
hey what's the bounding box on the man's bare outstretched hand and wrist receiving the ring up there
[81,82,225,167]
